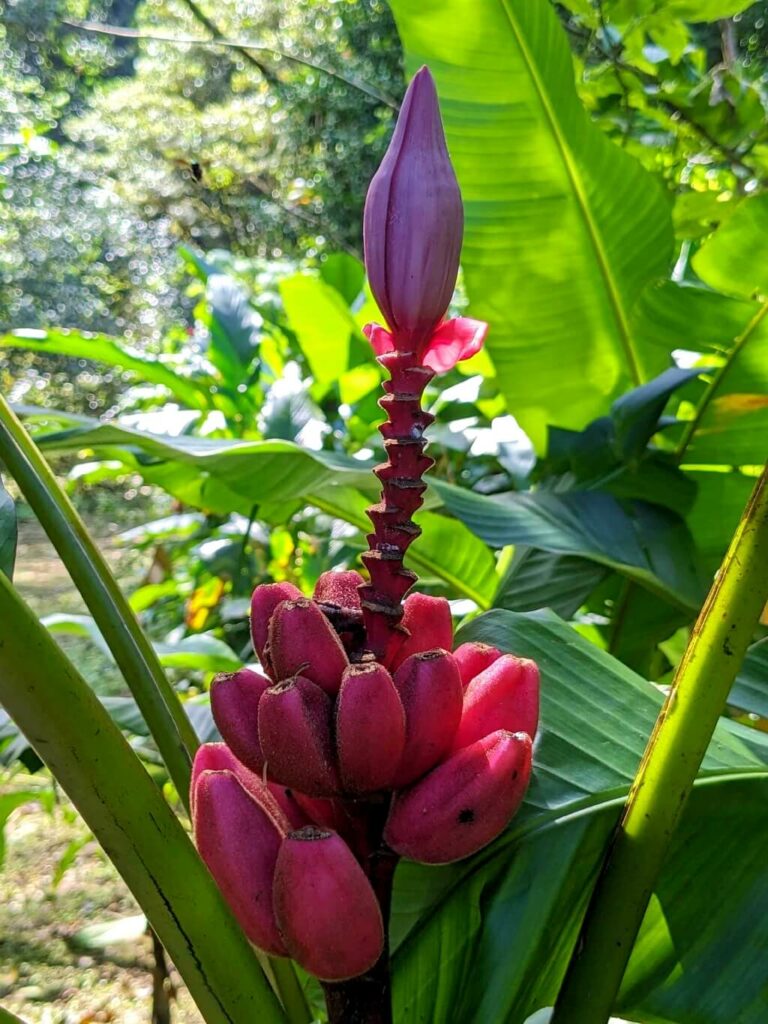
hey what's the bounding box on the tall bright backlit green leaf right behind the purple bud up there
[391,0,672,447]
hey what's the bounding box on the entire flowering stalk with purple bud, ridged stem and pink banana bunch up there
[191,69,539,1024]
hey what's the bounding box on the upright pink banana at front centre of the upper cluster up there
[336,662,406,793]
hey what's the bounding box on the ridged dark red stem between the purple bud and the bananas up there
[359,351,434,662]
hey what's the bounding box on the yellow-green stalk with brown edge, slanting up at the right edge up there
[551,467,768,1024]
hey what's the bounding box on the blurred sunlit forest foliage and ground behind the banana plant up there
[0,0,768,1024]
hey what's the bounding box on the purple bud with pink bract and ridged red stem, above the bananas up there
[360,68,485,660]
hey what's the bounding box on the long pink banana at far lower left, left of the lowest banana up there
[194,771,287,956]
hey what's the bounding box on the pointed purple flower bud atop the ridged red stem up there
[364,68,464,351]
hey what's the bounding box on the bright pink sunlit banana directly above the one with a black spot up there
[454,654,539,750]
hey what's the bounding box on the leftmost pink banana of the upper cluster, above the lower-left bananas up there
[211,669,272,772]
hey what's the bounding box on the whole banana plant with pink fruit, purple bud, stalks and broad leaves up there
[0,0,768,1024]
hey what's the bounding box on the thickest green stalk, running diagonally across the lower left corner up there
[0,573,286,1024]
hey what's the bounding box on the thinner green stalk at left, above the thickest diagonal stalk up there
[0,395,198,804]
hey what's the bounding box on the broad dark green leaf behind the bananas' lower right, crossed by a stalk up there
[393,611,768,1024]
